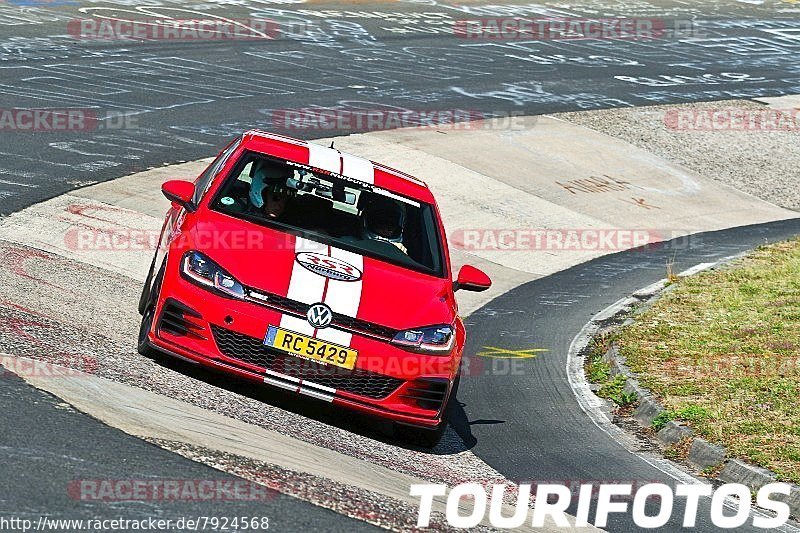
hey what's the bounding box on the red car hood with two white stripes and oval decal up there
[185,212,456,329]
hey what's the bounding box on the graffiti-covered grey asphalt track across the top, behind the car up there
[0,0,800,214]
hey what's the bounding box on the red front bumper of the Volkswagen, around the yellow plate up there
[148,276,458,428]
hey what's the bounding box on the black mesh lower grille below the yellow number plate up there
[211,325,403,399]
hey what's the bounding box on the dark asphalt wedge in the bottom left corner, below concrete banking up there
[0,373,377,532]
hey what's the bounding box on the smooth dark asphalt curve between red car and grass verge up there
[452,219,800,531]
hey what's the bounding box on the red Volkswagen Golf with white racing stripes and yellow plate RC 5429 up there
[138,131,491,446]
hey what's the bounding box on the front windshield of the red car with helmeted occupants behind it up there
[211,152,444,277]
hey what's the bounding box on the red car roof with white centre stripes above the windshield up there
[242,130,434,203]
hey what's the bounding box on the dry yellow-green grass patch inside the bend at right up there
[620,239,800,483]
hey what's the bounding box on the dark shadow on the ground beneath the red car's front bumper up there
[154,355,493,455]
